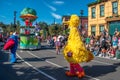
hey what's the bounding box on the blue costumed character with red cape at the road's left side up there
[3,32,18,63]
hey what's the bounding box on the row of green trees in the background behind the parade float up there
[0,21,66,38]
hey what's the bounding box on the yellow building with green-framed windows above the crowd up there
[88,0,120,36]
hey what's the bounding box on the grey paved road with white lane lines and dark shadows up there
[0,43,120,80]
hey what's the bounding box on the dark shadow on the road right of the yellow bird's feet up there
[83,63,117,77]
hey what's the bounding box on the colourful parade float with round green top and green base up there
[20,8,41,49]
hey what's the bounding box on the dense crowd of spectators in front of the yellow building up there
[84,29,120,59]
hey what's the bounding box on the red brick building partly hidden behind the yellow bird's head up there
[62,16,88,35]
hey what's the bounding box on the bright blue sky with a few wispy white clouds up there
[0,0,95,25]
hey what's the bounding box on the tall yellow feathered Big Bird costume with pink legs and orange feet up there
[63,15,94,78]
